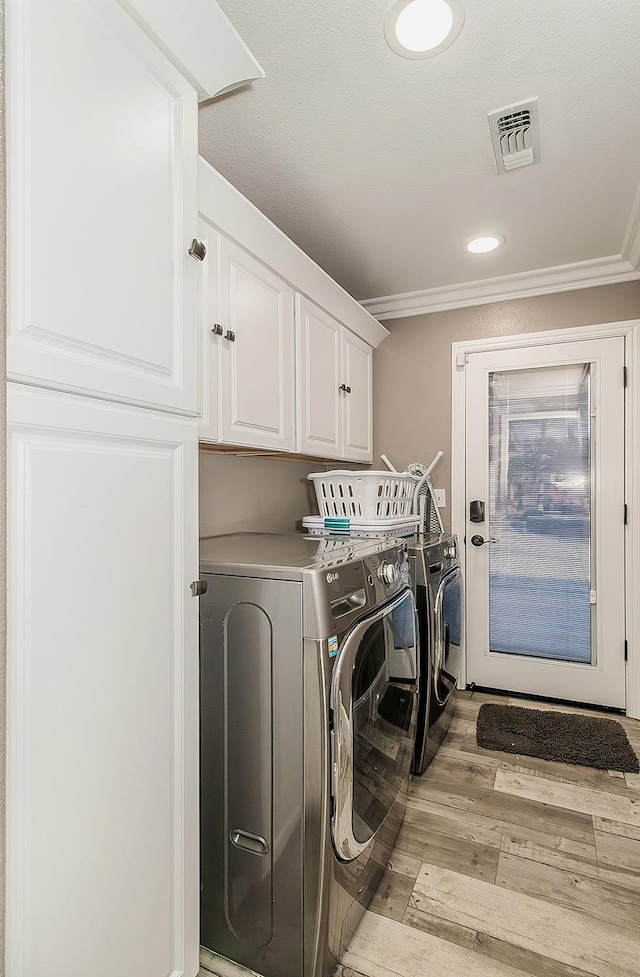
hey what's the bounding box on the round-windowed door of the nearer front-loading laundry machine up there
[331,590,417,861]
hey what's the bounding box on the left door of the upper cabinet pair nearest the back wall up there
[296,295,344,458]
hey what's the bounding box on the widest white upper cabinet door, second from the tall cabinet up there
[220,236,295,451]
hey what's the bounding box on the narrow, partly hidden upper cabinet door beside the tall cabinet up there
[198,217,222,442]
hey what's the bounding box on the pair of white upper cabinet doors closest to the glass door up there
[296,295,372,462]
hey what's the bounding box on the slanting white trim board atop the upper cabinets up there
[198,156,389,349]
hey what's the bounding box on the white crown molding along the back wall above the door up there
[361,255,640,320]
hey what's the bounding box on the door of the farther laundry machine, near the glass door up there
[432,567,462,705]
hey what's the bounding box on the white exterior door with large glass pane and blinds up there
[465,338,625,708]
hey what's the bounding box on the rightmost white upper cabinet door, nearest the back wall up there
[342,329,373,461]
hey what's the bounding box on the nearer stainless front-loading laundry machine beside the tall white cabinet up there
[200,534,417,977]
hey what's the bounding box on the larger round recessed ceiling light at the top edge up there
[384,0,464,58]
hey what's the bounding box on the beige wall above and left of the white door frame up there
[373,282,640,525]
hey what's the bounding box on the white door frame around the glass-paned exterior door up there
[451,319,640,719]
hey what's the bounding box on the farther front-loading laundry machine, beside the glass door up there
[409,535,463,774]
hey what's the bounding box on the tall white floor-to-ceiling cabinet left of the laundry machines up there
[5,0,262,977]
